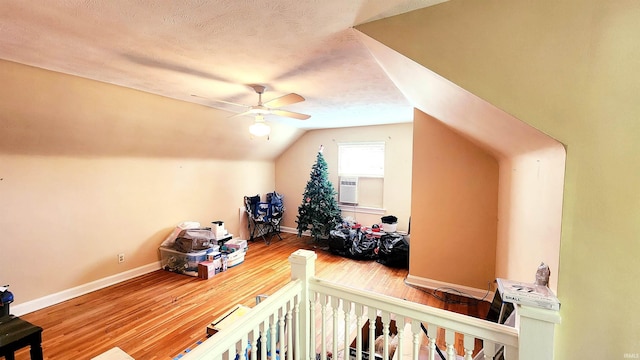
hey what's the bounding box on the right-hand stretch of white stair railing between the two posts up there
[310,278,520,360]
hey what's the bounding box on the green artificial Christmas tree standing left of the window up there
[296,146,342,241]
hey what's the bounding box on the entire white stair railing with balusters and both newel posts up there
[182,250,560,360]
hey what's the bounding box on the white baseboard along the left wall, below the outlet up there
[11,261,161,316]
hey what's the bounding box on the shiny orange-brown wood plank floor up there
[16,234,489,360]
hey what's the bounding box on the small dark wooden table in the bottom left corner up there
[0,315,42,360]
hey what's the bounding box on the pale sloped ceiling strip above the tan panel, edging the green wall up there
[359,33,562,159]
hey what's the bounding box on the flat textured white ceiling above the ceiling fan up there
[0,0,442,129]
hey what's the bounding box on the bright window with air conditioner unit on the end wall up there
[338,141,385,208]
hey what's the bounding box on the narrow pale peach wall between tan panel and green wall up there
[496,148,565,291]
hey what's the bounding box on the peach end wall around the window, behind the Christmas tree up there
[275,123,413,231]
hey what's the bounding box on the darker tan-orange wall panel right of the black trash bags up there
[409,110,498,289]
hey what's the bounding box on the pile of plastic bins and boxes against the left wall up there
[160,221,247,279]
